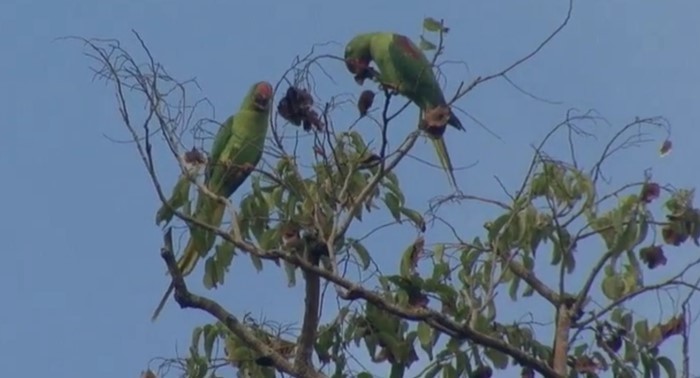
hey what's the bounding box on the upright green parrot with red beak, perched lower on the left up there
[151,81,273,320]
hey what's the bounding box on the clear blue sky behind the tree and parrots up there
[0,0,700,378]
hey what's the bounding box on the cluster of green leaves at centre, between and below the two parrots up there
[197,124,425,287]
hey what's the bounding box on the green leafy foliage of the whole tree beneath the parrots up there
[80,10,700,378]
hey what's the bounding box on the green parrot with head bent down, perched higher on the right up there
[345,32,464,188]
